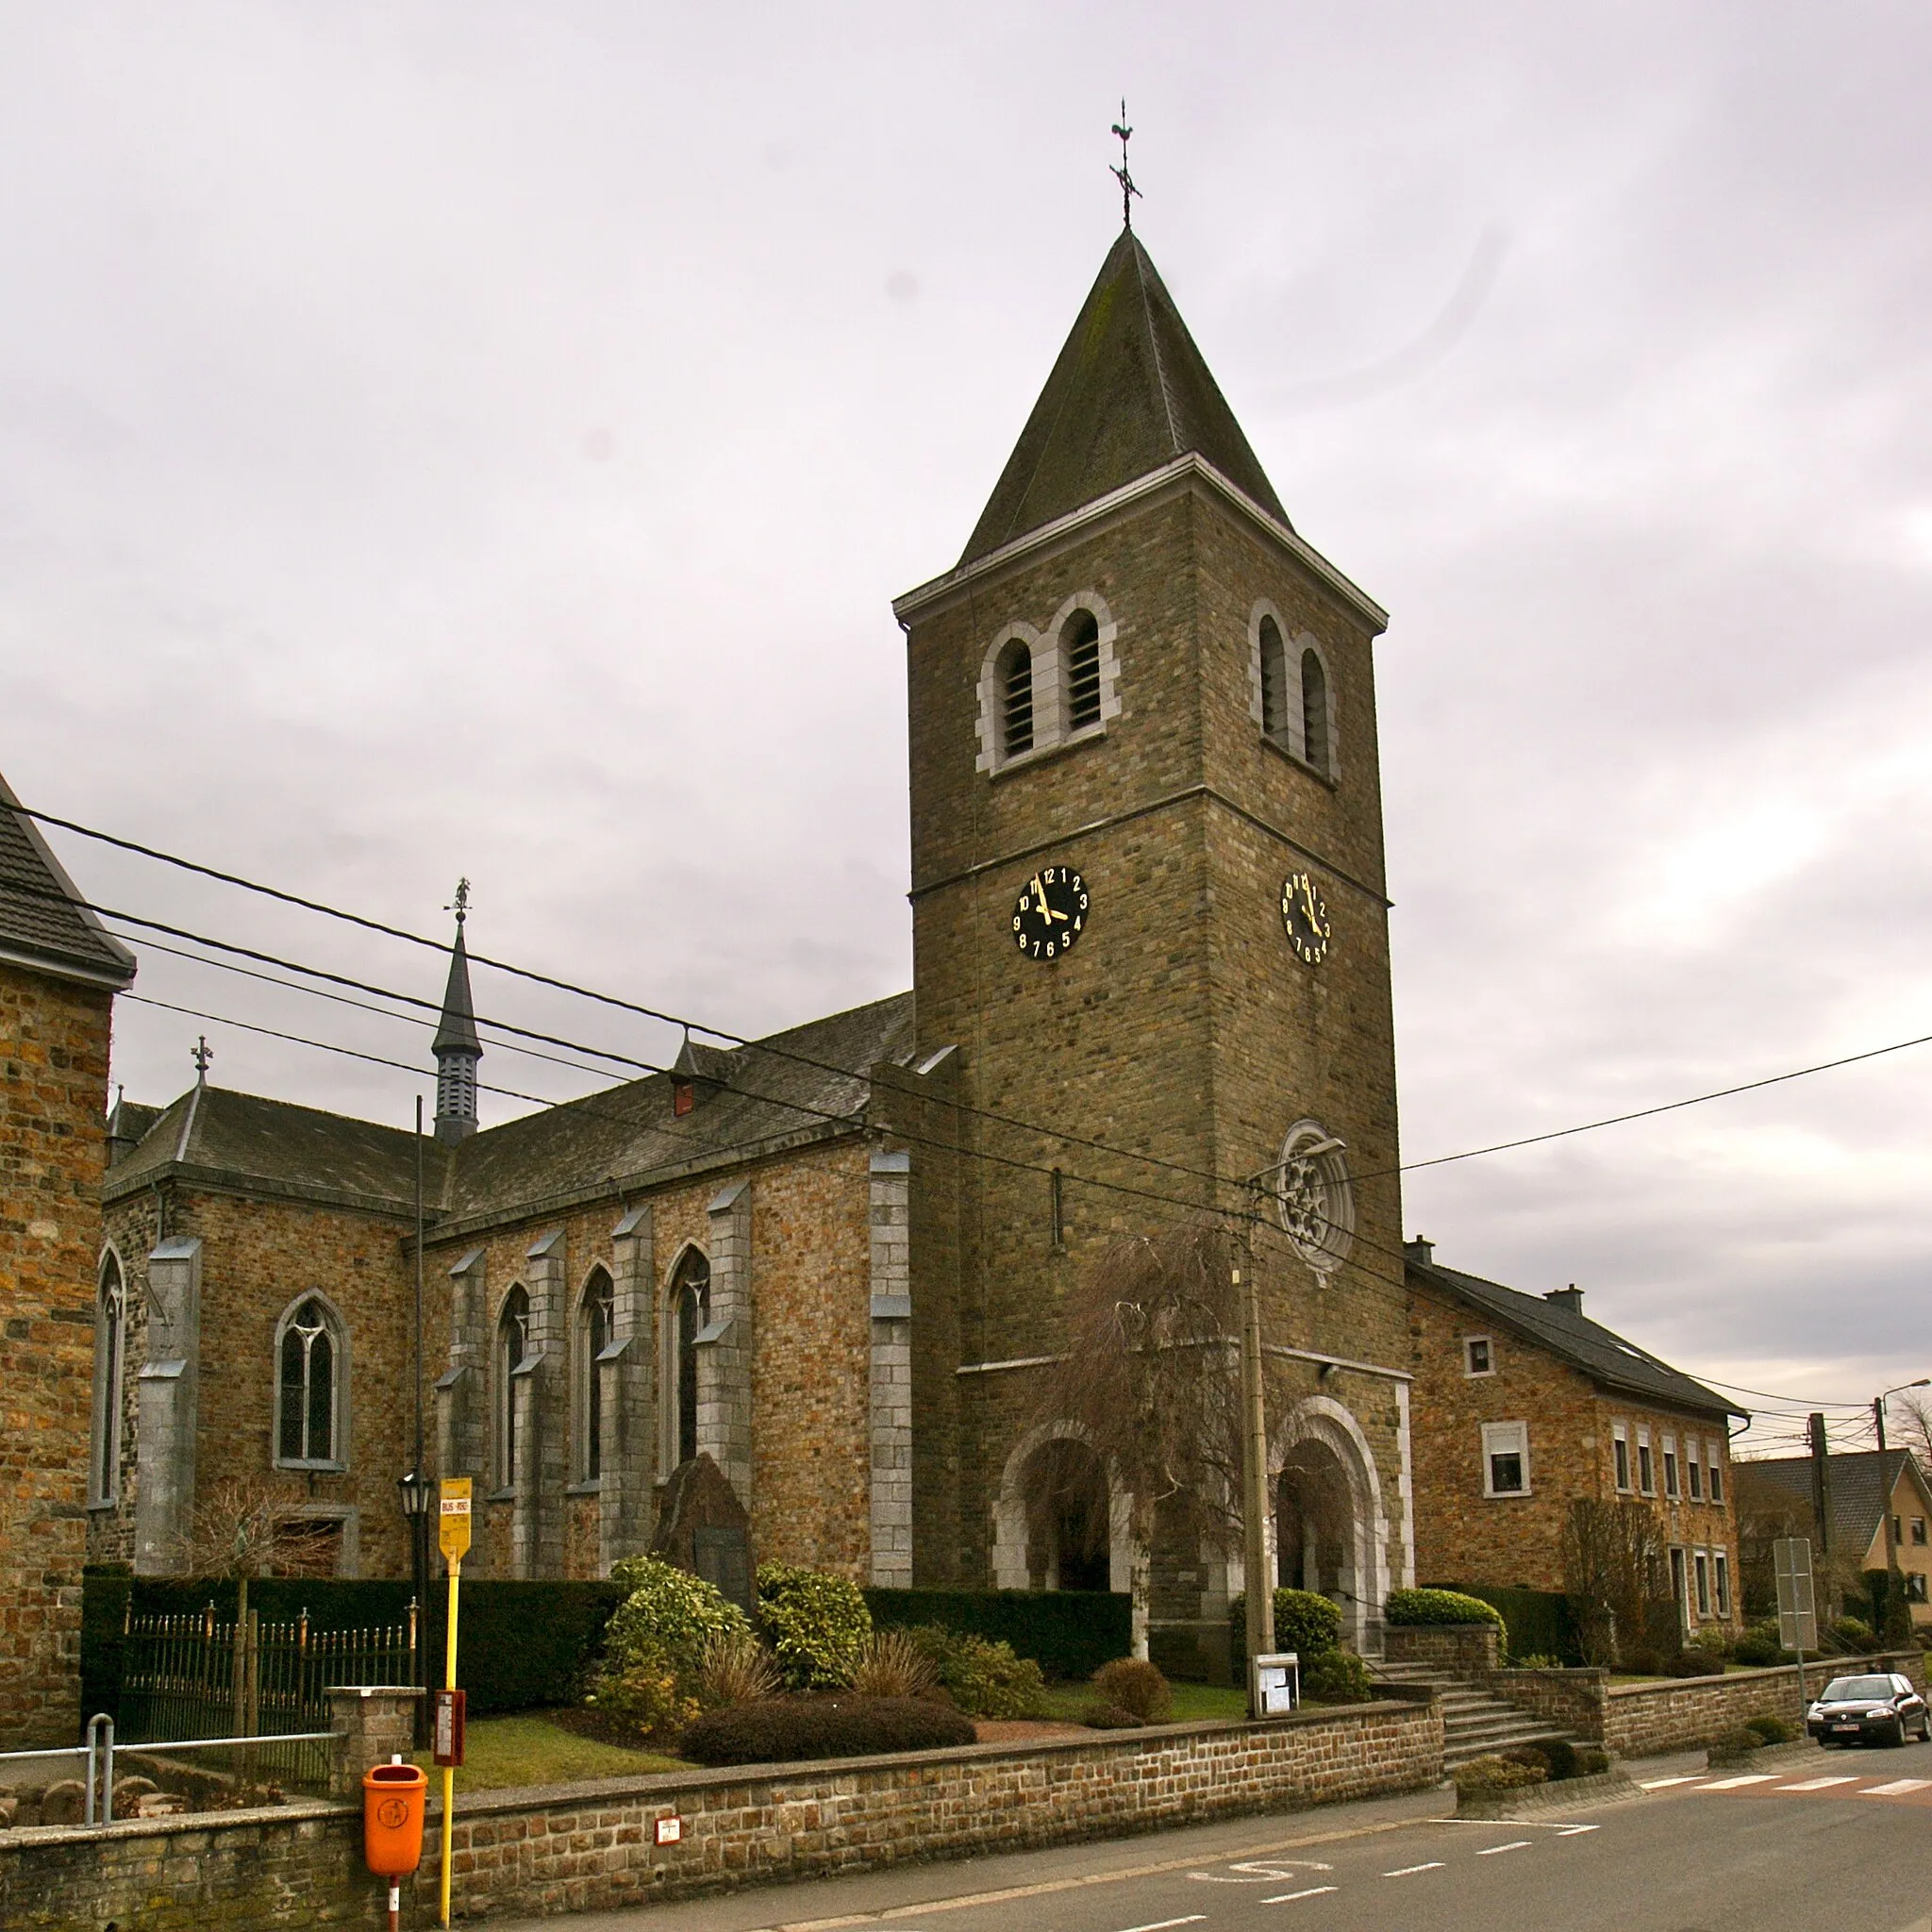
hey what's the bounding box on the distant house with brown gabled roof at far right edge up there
[1737,1449,1932,1628]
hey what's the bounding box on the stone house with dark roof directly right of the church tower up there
[1405,1241,1744,1637]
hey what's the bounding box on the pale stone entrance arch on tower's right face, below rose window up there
[1270,1395,1390,1656]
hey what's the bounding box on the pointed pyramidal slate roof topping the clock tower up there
[960,230,1289,564]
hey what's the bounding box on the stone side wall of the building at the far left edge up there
[0,966,112,1744]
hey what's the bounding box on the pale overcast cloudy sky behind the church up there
[0,0,1932,1441]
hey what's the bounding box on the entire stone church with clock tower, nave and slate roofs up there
[91,219,1414,1663]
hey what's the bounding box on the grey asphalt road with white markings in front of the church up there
[491,1746,1932,1932]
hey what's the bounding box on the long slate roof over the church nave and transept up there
[107,993,914,1223]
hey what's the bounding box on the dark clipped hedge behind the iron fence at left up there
[81,1569,625,1718]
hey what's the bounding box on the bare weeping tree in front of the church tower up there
[1032,1226,1292,1656]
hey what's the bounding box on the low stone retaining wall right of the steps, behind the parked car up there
[1488,1650,1926,1758]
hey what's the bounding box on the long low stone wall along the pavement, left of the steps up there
[0,1692,1443,1932]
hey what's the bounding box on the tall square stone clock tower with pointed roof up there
[894,230,1414,1661]
